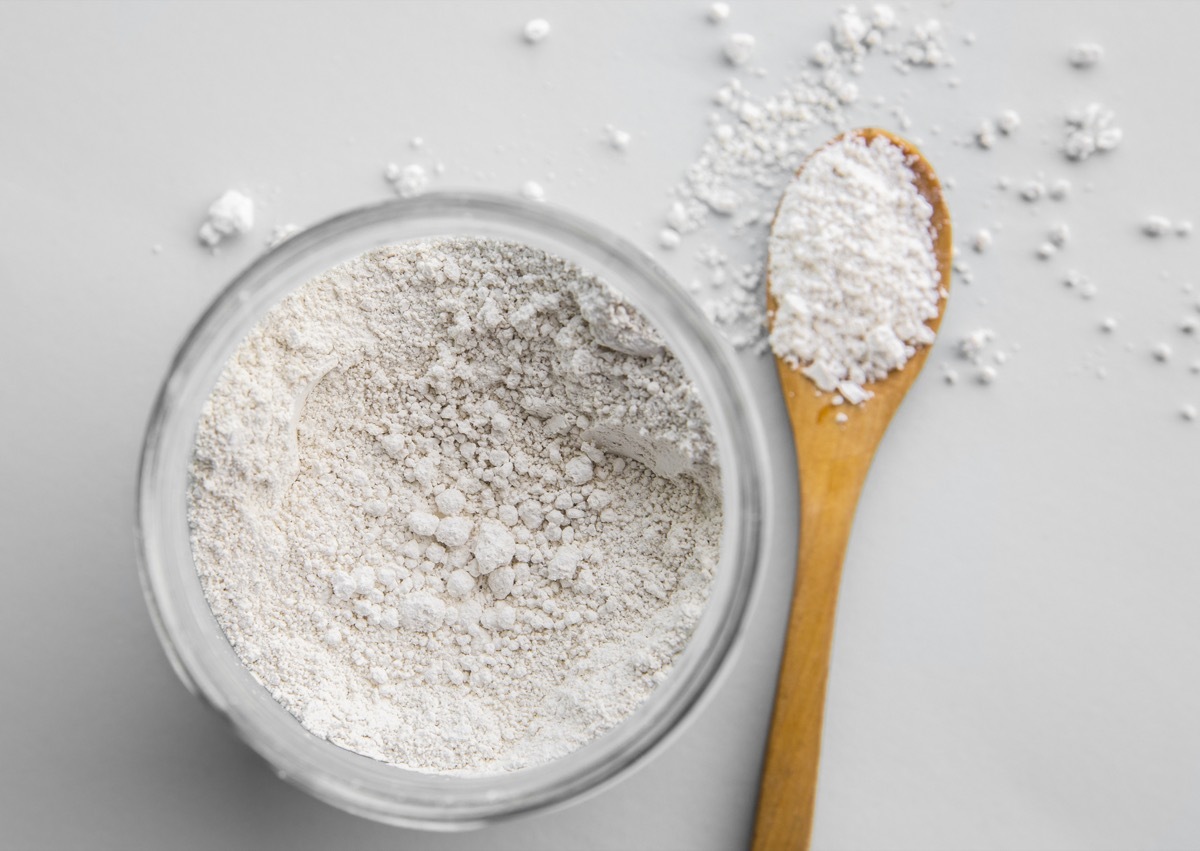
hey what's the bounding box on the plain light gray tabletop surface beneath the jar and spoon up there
[0,2,1200,849]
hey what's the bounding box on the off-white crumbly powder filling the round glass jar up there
[190,240,721,772]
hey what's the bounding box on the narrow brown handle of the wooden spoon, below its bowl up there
[752,439,874,851]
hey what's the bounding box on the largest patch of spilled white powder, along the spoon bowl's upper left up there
[666,4,953,350]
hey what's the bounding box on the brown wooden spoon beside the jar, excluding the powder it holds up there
[754,128,953,851]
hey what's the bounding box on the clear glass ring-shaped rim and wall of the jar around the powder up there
[137,193,766,829]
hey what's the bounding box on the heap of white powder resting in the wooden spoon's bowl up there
[768,136,941,401]
